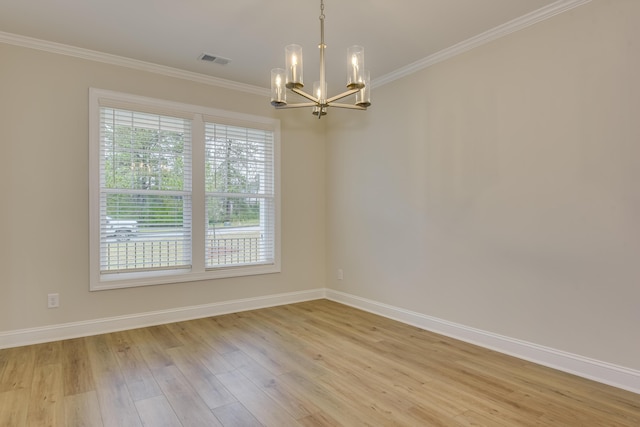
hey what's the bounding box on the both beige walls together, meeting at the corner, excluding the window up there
[0,0,640,369]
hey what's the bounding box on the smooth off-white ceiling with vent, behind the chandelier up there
[0,0,584,89]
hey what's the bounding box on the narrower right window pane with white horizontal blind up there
[205,122,275,268]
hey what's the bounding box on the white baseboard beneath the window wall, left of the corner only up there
[0,289,325,349]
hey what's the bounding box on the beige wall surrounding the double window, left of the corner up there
[0,44,325,332]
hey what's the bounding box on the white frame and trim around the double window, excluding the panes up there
[89,88,281,291]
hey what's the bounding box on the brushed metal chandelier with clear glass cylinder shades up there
[271,0,371,118]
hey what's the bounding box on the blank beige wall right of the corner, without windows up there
[327,0,640,369]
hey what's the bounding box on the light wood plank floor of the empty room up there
[0,300,640,427]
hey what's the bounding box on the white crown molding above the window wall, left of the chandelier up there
[0,31,270,96]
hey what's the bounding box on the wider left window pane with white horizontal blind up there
[100,107,192,274]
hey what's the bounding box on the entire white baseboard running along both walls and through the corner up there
[0,289,640,394]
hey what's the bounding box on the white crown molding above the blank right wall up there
[371,0,591,88]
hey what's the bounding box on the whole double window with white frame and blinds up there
[90,89,280,290]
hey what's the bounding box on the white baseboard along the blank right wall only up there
[326,289,640,394]
